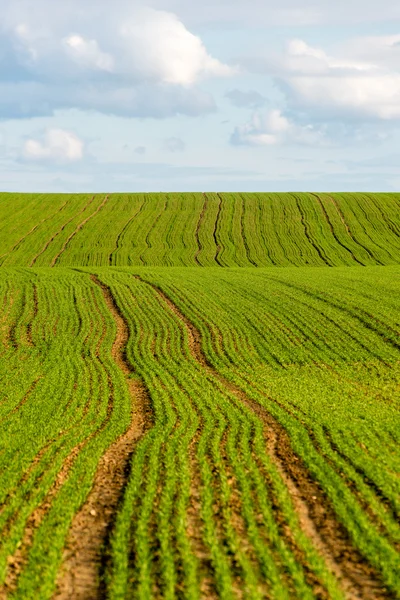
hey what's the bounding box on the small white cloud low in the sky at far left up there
[23,129,84,162]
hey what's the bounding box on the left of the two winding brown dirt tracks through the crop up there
[54,276,151,600]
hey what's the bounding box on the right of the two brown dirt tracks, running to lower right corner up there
[136,276,390,600]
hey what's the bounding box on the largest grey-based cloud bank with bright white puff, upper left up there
[0,0,235,118]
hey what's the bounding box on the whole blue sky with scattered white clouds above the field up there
[0,0,400,193]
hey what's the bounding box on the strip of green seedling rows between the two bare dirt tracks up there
[100,274,342,598]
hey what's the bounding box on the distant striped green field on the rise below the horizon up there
[0,193,400,267]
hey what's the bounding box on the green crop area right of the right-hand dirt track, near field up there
[141,268,400,597]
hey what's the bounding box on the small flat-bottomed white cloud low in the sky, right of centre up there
[230,110,324,146]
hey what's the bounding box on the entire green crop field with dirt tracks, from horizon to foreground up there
[0,194,400,600]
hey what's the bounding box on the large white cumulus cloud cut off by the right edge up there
[278,36,400,120]
